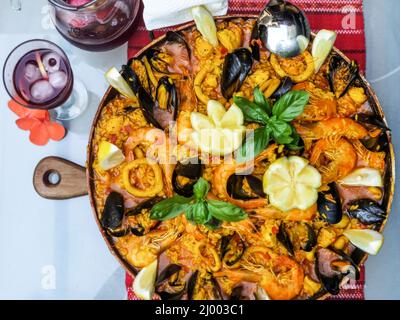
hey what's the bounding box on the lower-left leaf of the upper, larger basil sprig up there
[236,127,270,163]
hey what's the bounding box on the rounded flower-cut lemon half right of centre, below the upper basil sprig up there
[263,156,321,211]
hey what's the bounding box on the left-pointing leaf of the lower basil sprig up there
[150,196,192,221]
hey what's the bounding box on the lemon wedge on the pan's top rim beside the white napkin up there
[192,6,218,47]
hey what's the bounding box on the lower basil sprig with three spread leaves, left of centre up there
[150,178,247,230]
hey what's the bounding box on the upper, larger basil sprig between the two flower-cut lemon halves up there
[233,87,310,162]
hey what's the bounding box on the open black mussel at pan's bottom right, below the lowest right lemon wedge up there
[316,248,359,295]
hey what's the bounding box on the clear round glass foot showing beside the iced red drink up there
[50,79,88,121]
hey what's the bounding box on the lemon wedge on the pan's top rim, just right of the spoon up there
[311,29,336,73]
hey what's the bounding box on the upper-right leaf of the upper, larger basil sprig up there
[272,91,310,122]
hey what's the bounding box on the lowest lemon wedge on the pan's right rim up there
[343,229,383,255]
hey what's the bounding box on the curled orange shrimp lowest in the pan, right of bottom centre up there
[214,252,304,300]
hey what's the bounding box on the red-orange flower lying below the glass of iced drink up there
[8,100,65,146]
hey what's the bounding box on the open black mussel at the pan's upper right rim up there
[328,55,360,98]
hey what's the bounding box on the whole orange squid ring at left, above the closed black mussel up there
[122,158,163,198]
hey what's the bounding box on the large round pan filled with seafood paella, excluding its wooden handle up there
[87,11,394,299]
